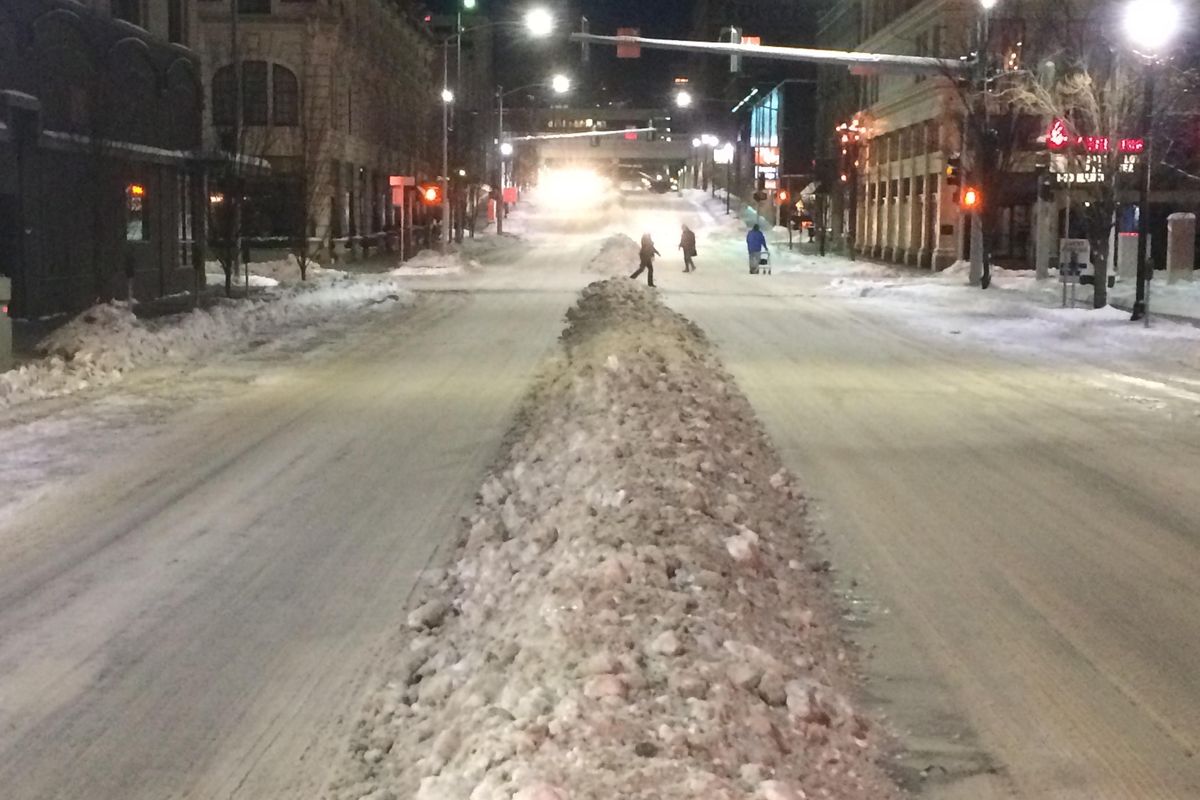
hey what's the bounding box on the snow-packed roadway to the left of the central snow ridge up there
[0,235,584,800]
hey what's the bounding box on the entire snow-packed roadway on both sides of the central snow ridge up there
[0,190,1200,800]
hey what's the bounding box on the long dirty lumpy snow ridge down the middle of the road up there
[330,278,898,800]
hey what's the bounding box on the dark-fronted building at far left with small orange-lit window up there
[0,0,203,318]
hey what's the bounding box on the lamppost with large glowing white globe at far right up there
[1123,0,1182,325]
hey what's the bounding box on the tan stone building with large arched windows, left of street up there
[198,0,440,258]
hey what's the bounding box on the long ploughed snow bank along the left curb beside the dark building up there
[0,275,413,407]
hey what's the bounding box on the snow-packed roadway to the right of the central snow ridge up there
[664,190,1200,800]
